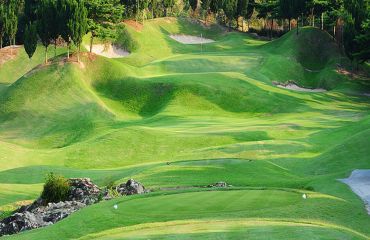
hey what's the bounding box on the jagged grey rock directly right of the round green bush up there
[67,178,101,205]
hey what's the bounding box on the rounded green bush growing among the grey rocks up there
[41,173,69,203]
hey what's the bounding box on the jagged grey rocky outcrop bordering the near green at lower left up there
[0,178,148,236]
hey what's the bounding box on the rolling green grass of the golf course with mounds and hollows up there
[0,17,370,240]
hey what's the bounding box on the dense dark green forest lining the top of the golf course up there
[0,0,370,63]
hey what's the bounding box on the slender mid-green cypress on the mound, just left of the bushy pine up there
[67,0,88,62]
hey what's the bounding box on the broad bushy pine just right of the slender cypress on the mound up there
[85,0,124,52]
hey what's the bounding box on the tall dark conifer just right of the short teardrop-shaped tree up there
[37,0,56,64]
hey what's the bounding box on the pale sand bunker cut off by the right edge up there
[339,169,370,215]
